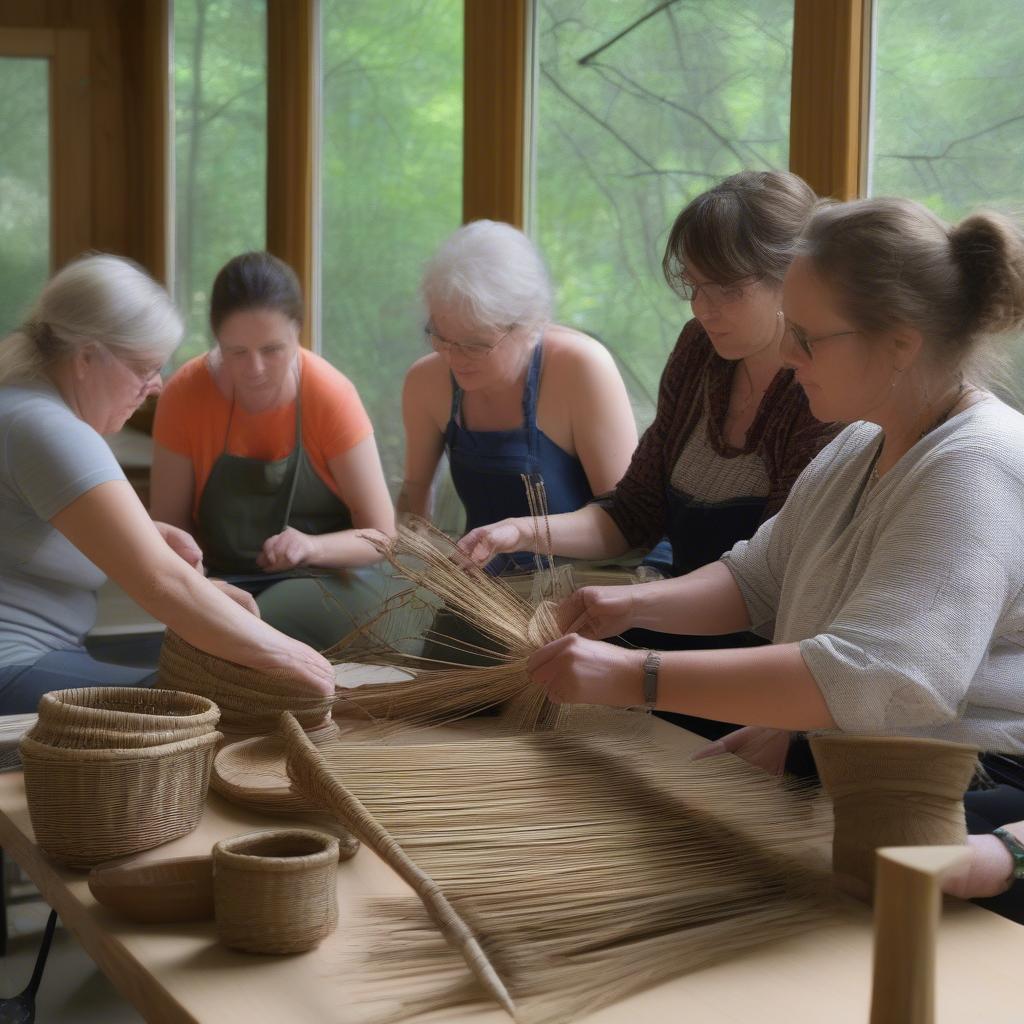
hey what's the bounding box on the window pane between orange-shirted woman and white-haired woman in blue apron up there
[321,0,463,489]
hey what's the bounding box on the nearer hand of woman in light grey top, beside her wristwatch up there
[527,633,647,708]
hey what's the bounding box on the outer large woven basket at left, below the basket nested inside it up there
[20,732,222,868]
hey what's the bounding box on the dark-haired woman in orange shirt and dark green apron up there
[152,252,394,647]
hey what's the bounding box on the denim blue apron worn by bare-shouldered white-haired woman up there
[444,342,594,572]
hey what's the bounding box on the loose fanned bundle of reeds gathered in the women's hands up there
[327,522,570,730]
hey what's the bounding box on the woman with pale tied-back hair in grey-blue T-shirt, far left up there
[0,255,334,714]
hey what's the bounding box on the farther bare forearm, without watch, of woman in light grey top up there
[632,562,751,636]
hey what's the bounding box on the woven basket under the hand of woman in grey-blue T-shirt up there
[159,630,334,735]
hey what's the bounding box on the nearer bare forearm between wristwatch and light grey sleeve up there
[657,643,836,730]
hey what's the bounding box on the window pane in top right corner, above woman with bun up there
[869,0,1024,220]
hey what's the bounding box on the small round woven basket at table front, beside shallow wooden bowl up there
[213,828,338,953]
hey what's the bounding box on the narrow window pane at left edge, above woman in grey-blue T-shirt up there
[0,57,50,337]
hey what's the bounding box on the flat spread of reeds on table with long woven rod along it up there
[282,716,829,1024]
